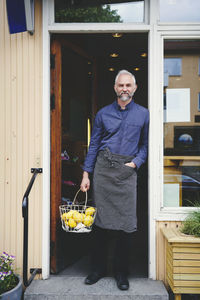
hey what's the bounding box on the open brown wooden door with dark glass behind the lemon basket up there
[51,35,96,273]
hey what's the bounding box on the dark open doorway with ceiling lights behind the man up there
[51,33,148,277]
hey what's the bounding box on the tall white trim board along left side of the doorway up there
[42,0,50,279]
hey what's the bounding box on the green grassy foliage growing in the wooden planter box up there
[181,209,200,237]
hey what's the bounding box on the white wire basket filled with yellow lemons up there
[59,189,97,233]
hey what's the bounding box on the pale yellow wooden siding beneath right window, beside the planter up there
[156,221,181,286]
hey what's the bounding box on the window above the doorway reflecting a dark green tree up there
[55,0,144,23]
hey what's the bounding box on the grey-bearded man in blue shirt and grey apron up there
[81,70,149,290]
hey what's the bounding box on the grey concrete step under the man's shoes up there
[24,275,169,300]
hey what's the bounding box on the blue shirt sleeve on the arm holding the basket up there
[83,113,103,173]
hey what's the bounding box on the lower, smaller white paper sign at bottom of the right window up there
[163,183,179,207]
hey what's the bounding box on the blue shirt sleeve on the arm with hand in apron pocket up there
[132,110,149,169]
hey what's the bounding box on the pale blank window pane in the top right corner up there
[160,0,200,22]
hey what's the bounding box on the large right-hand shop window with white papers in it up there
[163,40,200,207]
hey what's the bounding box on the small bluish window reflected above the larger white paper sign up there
[164,58,182,76]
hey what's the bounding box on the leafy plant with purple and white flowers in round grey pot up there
[0,252,19,295]
